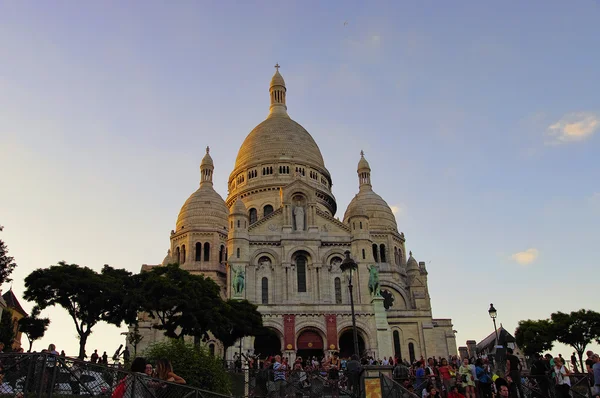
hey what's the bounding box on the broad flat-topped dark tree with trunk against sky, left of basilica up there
[23,261,136,358]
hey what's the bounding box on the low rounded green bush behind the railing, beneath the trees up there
[144,339,231,394]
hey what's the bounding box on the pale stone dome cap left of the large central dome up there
[176,184,229,232]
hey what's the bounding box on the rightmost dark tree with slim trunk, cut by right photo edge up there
[550,309,600,372]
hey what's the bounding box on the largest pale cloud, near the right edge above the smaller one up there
[547,112,600,144]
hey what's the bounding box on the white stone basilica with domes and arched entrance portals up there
[138,66,457,362]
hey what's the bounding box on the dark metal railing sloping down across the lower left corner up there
[0,353,231,398]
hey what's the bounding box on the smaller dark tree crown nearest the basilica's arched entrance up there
[210,299,263,356]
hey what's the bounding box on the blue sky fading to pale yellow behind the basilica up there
[0,0,600,356]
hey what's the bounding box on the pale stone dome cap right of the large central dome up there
[344,189,398,231]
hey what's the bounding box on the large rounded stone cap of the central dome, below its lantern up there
[235,116,326,171]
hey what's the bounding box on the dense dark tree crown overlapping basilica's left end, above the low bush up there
[138,264,223,338]
